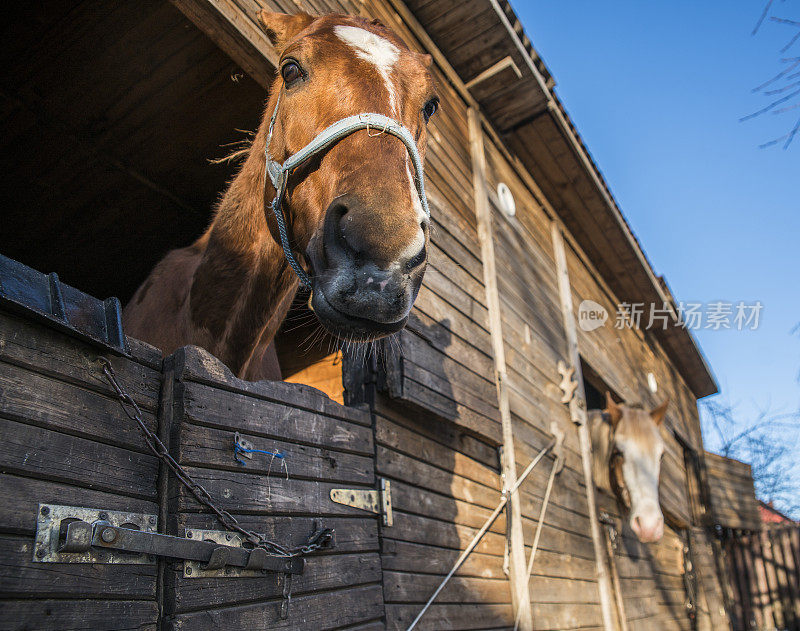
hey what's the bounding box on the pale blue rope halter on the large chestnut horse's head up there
[264,92,431,288]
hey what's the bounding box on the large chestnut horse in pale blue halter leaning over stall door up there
[124,11,438,380]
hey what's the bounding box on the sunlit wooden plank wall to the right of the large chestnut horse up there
[1,0,736,629]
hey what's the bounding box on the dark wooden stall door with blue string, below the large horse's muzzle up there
[159,347,384,631]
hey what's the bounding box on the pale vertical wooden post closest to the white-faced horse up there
[551,221,617,631]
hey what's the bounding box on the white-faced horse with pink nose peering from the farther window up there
[589,392,669,543]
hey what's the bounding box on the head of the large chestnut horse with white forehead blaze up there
[258,11,438,341]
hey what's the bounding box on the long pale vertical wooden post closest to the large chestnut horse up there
[468,107,533,631]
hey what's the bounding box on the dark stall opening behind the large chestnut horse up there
[0,0,343,402]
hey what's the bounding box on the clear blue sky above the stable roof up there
[512,0,800,460]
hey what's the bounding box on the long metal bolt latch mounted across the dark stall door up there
[33,504,304,578]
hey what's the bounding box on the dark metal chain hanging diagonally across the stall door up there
[98,357,333,557]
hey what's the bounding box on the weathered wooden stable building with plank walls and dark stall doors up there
[0,0,776,631]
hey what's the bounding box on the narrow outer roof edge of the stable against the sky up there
[460,0,719,399]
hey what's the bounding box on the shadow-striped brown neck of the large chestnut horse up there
[190,104,297,374]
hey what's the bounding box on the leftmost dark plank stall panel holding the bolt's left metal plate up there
[0,308,161,631]
